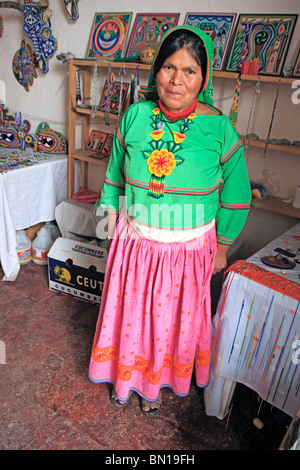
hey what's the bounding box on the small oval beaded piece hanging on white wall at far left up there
[12,40,38,91]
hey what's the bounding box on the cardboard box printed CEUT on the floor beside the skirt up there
[48,238,107,304]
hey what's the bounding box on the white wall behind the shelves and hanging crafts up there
[0,0,300,198]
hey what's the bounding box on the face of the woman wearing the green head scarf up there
[156,48,203,113]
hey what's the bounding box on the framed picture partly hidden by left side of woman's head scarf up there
[126,13,179,57]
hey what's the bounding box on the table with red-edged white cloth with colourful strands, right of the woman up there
[204,224,300,419]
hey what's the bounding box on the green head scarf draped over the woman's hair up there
[139,25,214,104]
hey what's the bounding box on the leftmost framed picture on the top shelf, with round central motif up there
[87,13,132,59]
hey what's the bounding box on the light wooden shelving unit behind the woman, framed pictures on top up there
[68,59,300,218]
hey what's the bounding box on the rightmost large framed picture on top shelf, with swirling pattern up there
[226,14,298,76]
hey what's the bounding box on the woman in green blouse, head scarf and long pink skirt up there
[89,26,251,416]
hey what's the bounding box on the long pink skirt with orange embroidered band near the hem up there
[89,217,216,402]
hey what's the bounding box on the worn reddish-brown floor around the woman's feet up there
[0,263,290,452]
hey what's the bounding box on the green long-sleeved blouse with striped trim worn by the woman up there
[96,101,251,244]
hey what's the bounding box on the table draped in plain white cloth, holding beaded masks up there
[0,152,77,281]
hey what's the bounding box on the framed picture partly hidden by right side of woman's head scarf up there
[184,13,236,70]
